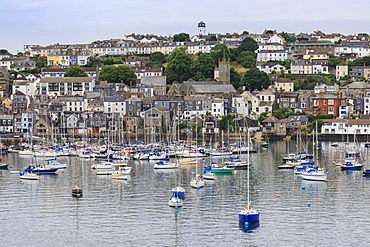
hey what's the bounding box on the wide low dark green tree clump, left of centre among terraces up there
[99,65,136,84]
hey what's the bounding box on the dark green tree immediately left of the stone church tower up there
[194,53,216,81]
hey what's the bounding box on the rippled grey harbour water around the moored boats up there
[0,141,370,246]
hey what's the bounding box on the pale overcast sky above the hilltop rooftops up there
[0,0,370,53]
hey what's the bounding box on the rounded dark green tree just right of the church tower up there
[242,68,271,91]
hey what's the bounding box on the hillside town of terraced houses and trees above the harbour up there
[0,22,370,144]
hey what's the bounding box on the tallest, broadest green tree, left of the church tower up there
[164,47,194,83]
